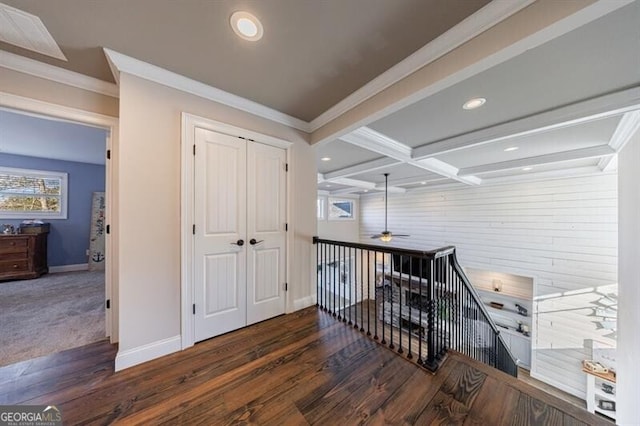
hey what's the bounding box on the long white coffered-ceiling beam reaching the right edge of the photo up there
[413,86,640,159]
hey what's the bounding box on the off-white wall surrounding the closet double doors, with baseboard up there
[113,74,316,368]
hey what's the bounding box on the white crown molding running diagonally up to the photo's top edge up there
[309,0,535,132]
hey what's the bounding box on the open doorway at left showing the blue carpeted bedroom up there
[0,94,117,366]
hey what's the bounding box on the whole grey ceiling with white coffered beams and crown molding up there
[0,0,640,194]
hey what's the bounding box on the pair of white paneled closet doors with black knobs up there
[193,128,286,341]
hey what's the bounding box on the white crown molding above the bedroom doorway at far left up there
[0,50,120,98]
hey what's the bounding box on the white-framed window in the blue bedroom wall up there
[0,166,67,219]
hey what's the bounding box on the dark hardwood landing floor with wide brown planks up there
[0,308,611,425]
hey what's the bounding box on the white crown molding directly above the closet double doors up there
[103,48,309,133]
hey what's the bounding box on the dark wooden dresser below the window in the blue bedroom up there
[0,232,49,281]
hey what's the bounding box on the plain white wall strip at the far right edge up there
[616,133,640,425]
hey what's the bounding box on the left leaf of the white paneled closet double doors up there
[194,129,247,341]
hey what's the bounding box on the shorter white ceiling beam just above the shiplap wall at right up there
[460,145,616,176]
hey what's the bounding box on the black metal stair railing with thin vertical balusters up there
[313,237,518,376]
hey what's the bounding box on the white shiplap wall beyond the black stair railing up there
[360,174,618,398]
